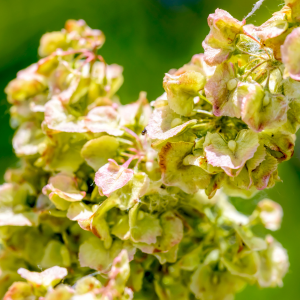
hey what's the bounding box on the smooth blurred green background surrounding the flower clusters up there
[0,0,300,300]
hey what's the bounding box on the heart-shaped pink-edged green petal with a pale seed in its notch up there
[203,129,259,174]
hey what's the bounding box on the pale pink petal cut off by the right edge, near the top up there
[281,27,300,81]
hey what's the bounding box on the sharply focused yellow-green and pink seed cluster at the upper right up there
[147,1,300,197]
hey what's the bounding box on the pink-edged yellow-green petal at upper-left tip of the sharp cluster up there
[202,9,244,65]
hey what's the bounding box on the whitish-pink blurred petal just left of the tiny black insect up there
[85,106,123,136]
